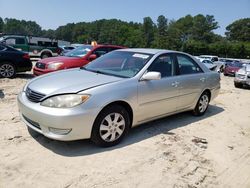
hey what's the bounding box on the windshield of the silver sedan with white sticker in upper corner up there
[84,51,152,78]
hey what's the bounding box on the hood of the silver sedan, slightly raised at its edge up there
[27,68,124,95]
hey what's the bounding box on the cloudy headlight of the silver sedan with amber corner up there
[41,94,89,108]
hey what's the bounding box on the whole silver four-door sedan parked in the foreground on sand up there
[18,49,220,146]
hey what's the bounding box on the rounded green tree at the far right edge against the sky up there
[225,18,250,42]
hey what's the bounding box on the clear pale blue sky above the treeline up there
[0,0,250,35]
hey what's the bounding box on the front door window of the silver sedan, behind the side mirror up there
[148,54,174,78]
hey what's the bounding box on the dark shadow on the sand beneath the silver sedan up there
[28,105,224,157]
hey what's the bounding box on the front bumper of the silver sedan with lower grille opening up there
[17,92,98,141]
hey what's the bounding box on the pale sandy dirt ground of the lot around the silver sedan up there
[0,74,250,188]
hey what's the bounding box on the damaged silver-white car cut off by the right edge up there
[234,64,250,88]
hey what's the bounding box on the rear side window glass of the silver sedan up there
[176,54,202,75]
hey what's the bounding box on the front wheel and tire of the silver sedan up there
[91,105,130,147]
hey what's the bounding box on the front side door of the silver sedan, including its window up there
[138,54,178,122]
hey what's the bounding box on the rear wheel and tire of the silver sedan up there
[193,91,210,116]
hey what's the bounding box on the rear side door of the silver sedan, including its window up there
[176,53,207,110]
